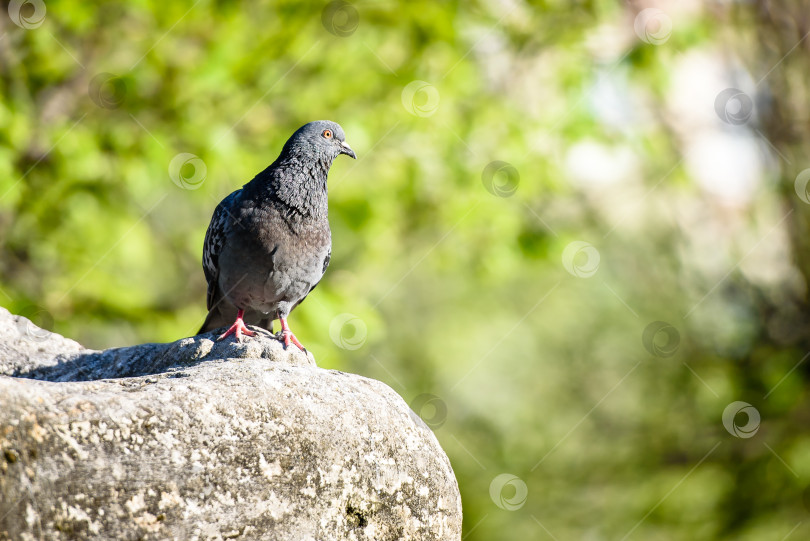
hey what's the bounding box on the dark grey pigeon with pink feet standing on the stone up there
[197,120,357,351]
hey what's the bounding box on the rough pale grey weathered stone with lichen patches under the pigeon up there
[0,309,461,540]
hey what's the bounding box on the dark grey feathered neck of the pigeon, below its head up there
[246,153,332,219]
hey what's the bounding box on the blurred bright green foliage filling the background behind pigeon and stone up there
[0,0,810,540]
